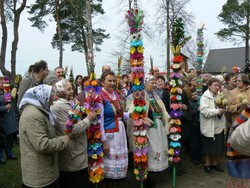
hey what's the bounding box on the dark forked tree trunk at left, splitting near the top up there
[10,0,27,82]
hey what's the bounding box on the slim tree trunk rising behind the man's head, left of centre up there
[55,0,63,67]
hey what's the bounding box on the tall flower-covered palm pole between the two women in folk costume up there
[126,0,148,187]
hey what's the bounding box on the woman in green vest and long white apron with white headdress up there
[127,75,170,172]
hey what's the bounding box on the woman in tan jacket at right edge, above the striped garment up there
[228,74,250,122]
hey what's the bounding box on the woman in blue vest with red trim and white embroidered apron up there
[100,71,129,186]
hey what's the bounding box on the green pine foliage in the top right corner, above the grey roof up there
[215,0,250,44]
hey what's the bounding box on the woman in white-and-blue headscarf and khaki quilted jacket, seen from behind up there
[19,85,69,187]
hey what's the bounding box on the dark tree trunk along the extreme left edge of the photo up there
[0,0,11,78]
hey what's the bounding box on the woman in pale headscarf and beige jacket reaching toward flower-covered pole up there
[51,80,95,188]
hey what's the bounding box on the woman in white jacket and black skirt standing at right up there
[200,78,226,174]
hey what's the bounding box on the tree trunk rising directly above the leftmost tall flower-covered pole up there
[85,0,95,75]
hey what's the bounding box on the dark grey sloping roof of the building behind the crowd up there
[203,47,250,73]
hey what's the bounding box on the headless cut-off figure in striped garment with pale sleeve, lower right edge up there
[227,106,250,188]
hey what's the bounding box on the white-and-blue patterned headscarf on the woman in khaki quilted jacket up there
[19,84,55,125]
